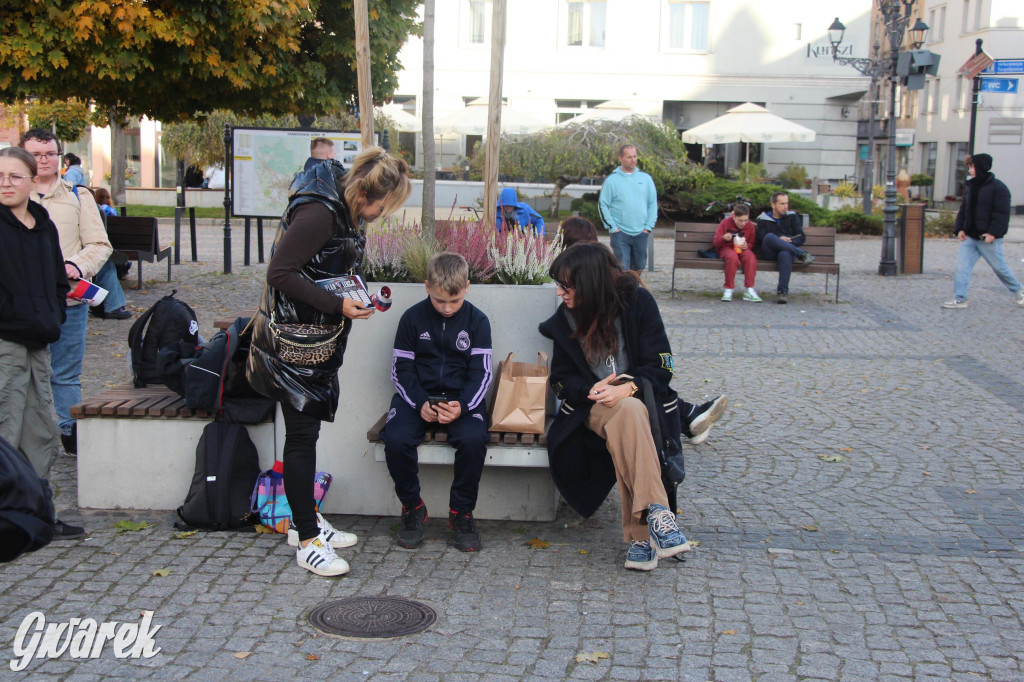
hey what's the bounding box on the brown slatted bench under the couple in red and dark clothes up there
[672,222,839,303]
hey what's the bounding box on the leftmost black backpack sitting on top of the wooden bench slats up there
[128,289,199,388]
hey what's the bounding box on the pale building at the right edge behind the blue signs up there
[911,0,1024,201]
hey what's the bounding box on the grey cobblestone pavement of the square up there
[0,216,1024,682]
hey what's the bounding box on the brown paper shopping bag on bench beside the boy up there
[490,352,548,433]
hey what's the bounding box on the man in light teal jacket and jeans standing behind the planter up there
[600,144,657,271]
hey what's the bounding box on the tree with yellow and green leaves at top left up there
[0,0,419,199]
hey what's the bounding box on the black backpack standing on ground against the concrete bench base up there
[174,421,260,530]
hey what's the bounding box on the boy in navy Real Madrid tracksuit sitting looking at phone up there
[381,253,493,552]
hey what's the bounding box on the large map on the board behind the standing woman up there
[231,128,362,218]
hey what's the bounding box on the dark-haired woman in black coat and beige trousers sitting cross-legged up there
[540,244,708,570]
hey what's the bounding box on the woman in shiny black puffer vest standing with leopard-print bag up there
[247,147,412,576]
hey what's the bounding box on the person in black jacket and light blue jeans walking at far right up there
[942,154,1024,308]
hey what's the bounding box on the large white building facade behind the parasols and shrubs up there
[395,0,871,180]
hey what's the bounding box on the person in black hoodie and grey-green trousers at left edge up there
[0,146,85,540]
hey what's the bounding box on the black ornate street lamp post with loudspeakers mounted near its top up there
[828,0,928,276]
